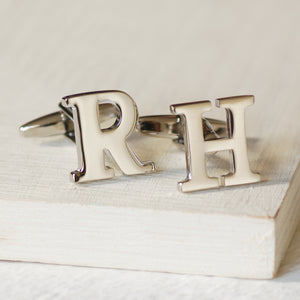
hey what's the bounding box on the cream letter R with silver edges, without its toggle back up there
[62,91,155,182]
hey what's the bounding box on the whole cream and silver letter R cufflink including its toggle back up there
[20,91,155,182]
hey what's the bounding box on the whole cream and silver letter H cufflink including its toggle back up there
[139,95,260,192]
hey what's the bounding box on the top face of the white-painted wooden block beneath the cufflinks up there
[0,1,300,296]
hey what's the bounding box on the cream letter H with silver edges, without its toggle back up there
[170,96,260,192]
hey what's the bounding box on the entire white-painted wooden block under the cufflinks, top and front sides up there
[0,1,300,278]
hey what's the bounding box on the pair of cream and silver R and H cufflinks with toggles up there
[20,91,260,192]
